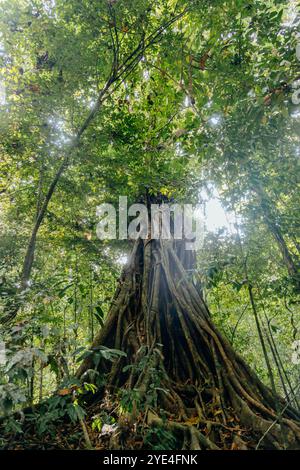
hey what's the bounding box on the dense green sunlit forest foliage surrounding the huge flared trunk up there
[0,0,300,449]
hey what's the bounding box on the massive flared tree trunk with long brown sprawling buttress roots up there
[77,239,300,449]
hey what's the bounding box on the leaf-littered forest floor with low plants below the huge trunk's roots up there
[0,394,259,450]
